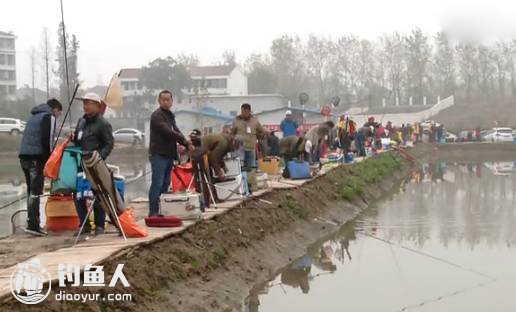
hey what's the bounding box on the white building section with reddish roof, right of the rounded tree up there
[189,65,247,96]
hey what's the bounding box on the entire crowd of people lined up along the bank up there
[19,90,445,235]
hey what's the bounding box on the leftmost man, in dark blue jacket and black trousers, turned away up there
[19,99,63,236]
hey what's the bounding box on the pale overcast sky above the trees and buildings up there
[0,0,516,87]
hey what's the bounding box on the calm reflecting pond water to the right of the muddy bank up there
[245,162,516,312]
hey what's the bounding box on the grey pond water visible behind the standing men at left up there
[0,152,150,237]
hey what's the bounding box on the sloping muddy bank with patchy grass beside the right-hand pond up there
[1,145,424,311]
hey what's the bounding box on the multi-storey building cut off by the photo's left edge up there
[0,31,16,99]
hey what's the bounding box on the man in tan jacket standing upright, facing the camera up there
[231,103,265,168]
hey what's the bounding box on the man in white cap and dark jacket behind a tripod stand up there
[73,93,114,235]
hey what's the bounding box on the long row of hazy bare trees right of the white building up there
[245,28,516,106]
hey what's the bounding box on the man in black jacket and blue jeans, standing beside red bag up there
[149,90,194,216]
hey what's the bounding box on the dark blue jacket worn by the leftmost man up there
[19,103,53,161]
